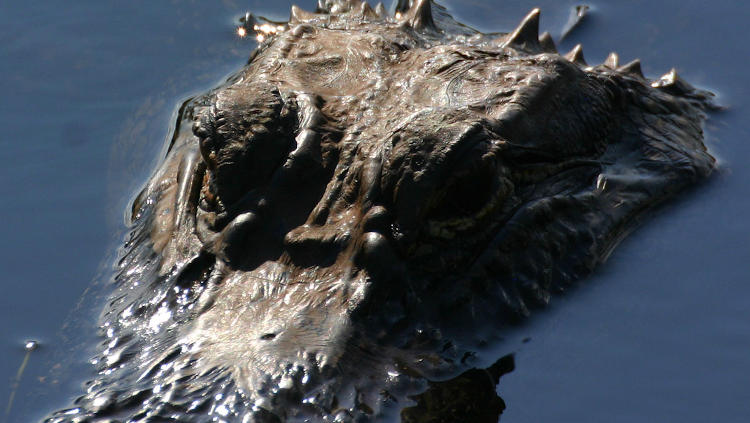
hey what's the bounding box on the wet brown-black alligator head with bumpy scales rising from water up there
[46,0,715,422]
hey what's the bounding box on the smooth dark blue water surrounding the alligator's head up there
[0,0,750,422]
